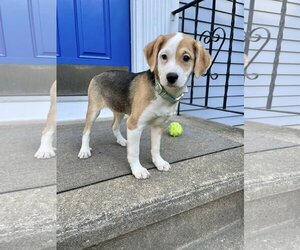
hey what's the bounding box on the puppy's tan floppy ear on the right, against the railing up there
[194,41,211,78]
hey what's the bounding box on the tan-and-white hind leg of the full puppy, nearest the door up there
[78,80,105,159]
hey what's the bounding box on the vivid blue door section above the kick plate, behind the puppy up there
[57,0,130,68]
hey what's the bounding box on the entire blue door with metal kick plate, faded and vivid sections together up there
[0,0,130,95]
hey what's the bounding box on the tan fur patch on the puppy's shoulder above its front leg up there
[127,74,155,130]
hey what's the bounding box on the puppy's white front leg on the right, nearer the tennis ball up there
[151,126,170,171]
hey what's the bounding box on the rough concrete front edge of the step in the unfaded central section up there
[57,173,244,247]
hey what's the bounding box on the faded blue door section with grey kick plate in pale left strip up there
[0,0,56,96]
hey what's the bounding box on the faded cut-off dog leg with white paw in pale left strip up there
[34,81,56,159]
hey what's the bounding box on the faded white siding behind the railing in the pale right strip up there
[245,0,300,125]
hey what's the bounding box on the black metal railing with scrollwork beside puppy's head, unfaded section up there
[172,0,243,114]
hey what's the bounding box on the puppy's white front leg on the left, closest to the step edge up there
[127,127,150,179]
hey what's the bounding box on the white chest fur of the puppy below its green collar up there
[138,95,178,127]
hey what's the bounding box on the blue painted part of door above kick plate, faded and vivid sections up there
[0,0,130,67]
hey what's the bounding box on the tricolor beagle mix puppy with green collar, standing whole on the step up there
[78,33,211,179]
